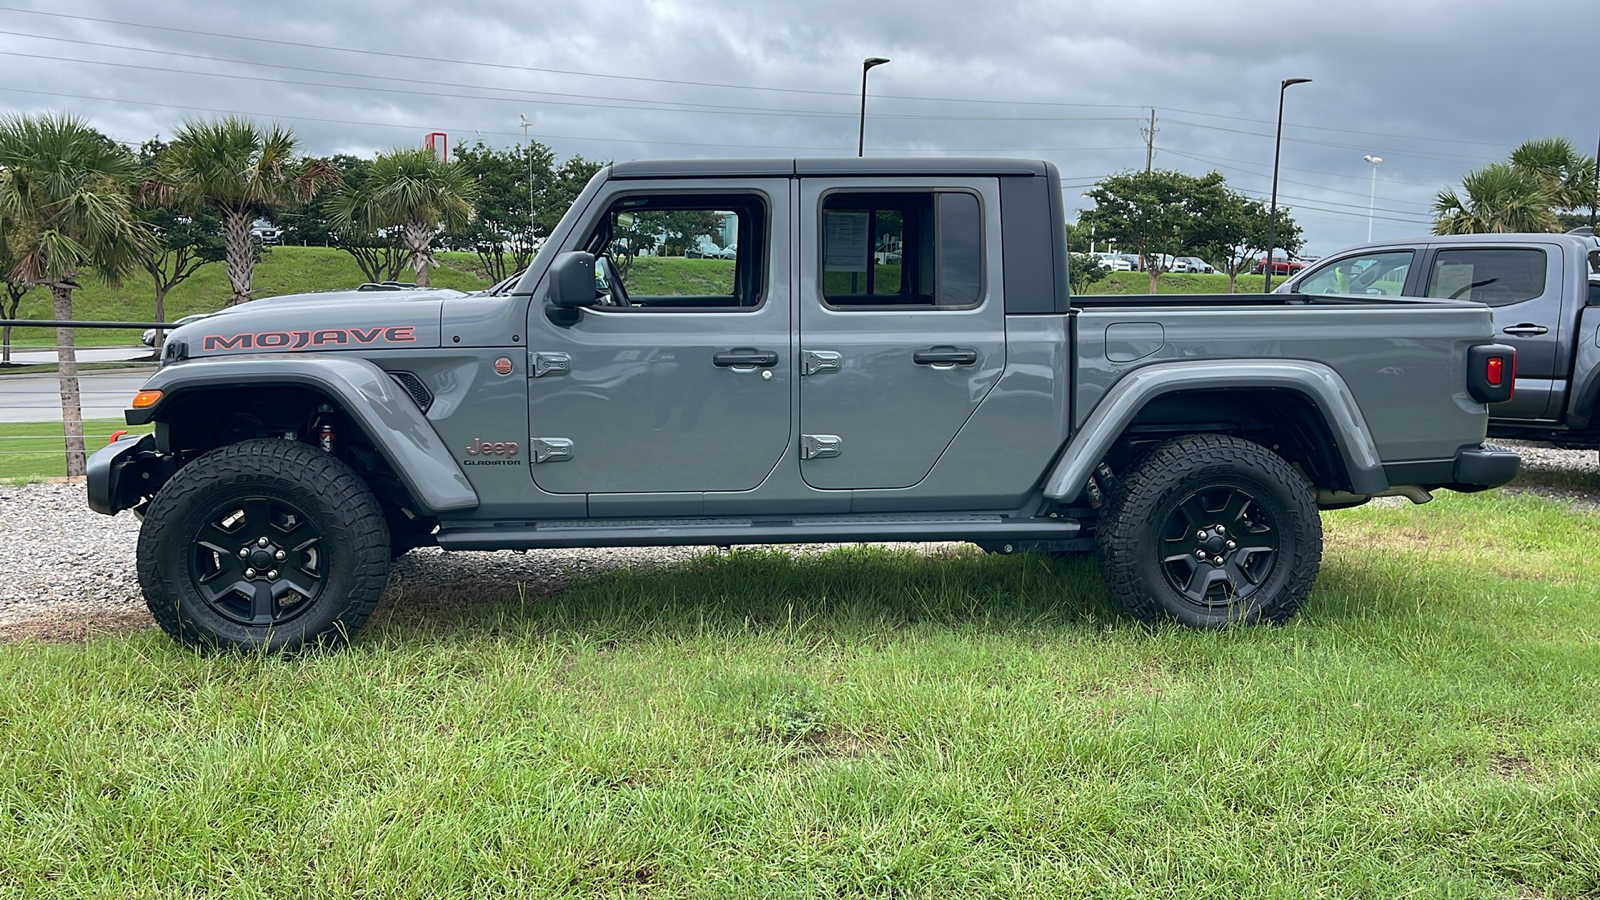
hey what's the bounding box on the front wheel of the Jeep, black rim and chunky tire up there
[138,439,390,652]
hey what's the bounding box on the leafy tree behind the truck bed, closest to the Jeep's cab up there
[1078,168,1224,293]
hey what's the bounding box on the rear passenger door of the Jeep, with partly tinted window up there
[798,178,1005,488]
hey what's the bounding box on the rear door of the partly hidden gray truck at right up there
[1424,243,1573,420]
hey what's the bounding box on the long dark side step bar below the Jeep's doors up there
[435,514,1080,549]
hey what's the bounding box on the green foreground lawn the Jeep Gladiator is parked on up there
[0,493,1600,898]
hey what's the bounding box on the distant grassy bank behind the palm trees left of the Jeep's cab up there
[11,247,488,346]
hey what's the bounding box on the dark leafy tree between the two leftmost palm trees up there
[134,141,227,342]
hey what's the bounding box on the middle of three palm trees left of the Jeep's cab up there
[163,115,338,304]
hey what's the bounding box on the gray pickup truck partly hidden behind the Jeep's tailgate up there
[1277,234,1600,450]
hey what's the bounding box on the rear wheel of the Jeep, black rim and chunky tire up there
[1096,434,1322,628]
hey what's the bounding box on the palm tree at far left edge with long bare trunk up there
[0,114,144,476]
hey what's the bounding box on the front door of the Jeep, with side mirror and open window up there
[528,179,795,493]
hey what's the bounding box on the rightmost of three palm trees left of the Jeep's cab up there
[328,149,477,287]
